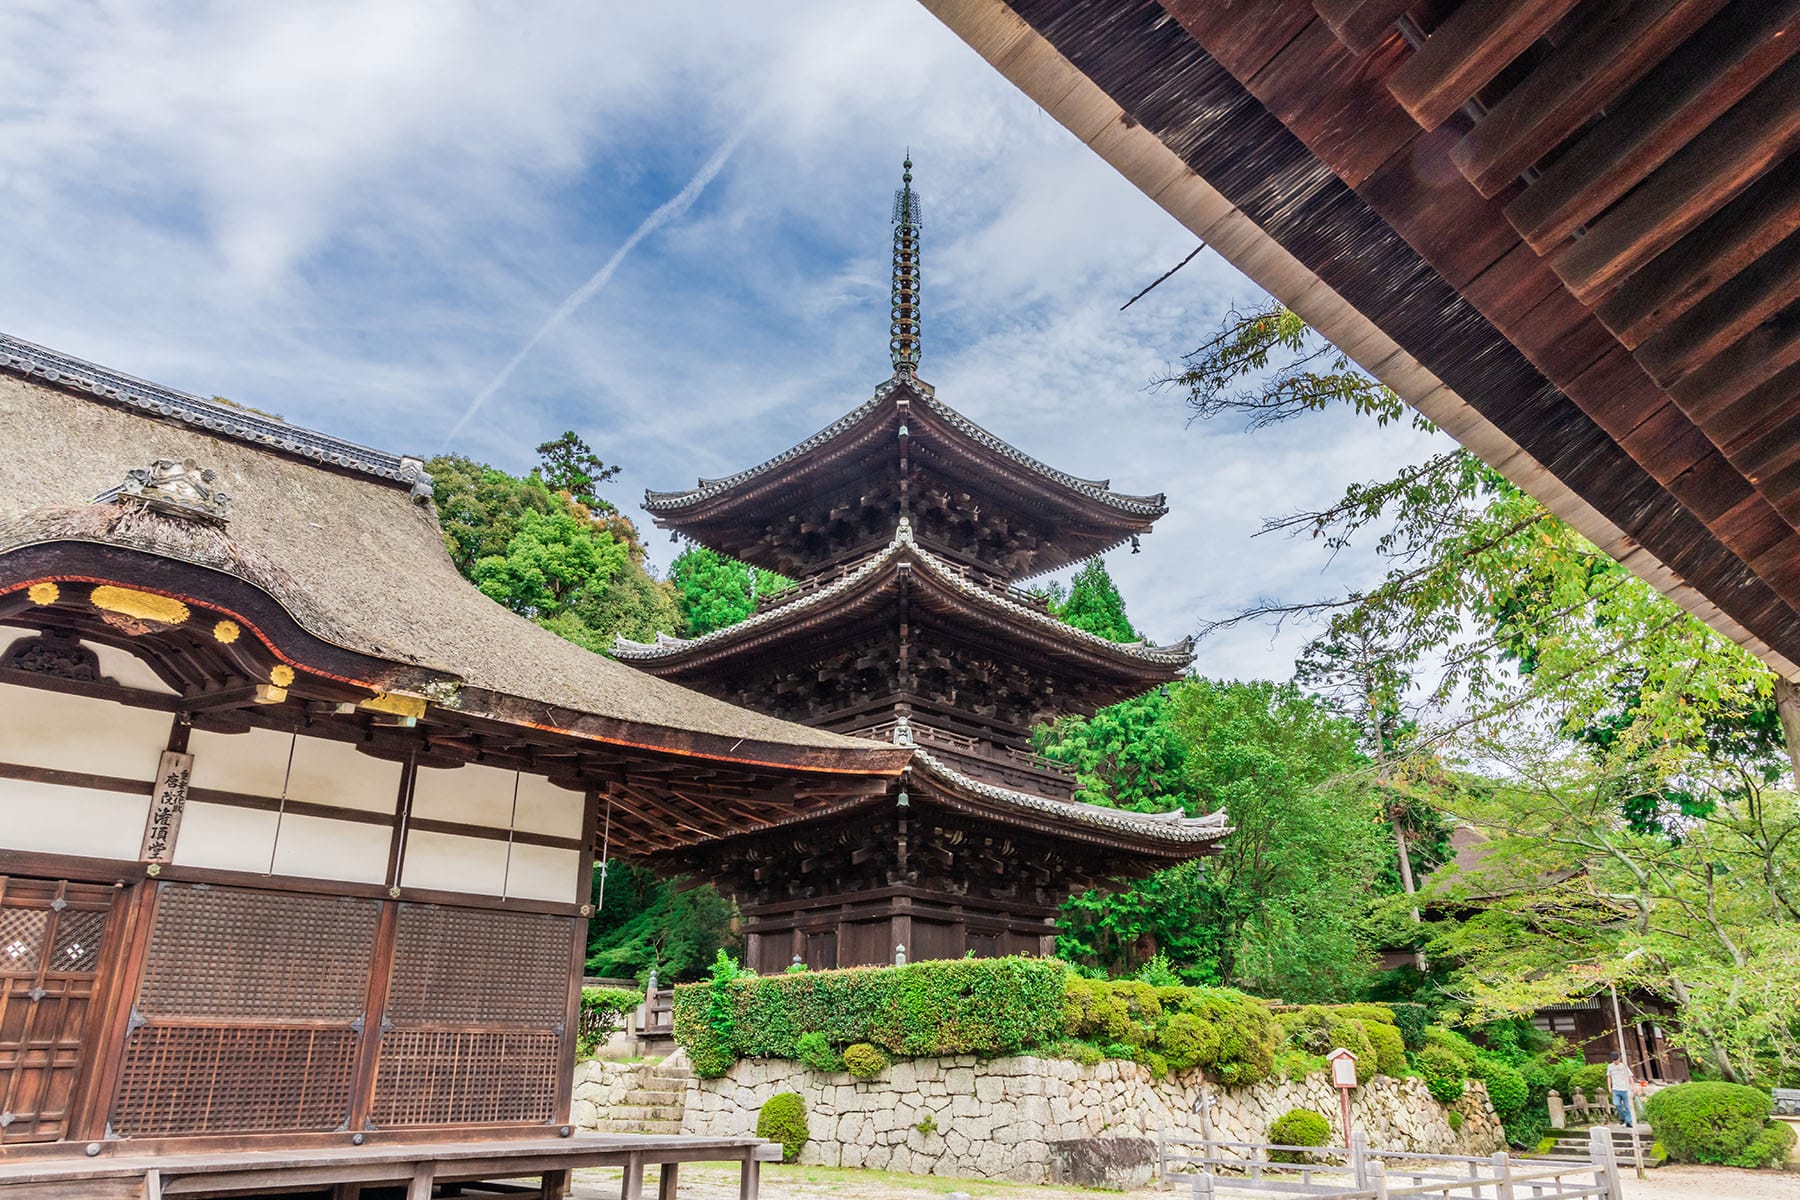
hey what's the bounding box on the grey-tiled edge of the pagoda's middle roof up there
[612,518,1193,675]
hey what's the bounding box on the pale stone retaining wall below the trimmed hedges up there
[644,1058,1505,1184]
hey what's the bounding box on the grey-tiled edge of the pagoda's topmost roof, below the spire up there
[644,374,1168,525]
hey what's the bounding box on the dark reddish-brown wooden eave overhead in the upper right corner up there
[923,0,1800,678]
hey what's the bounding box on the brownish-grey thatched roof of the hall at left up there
[0,340,904,774]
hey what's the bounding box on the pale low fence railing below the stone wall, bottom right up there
[1157,1130,1624,1200]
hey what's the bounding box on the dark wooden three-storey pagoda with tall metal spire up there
[616,162,1226,972]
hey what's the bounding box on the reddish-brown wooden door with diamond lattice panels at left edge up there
[0,876,117,1146]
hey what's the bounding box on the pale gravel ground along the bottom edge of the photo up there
[574,1166,1800,1200]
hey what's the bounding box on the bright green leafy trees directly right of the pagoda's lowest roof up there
[1039,680,1384,1000]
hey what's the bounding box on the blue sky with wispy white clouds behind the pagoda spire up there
[0,0,1436,678]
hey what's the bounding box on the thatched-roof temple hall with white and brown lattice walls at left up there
[0,336,911,1195]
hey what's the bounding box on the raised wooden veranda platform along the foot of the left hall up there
[0,1133,781,1200]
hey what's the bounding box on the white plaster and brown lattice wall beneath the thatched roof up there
[0,626,594,1153]
